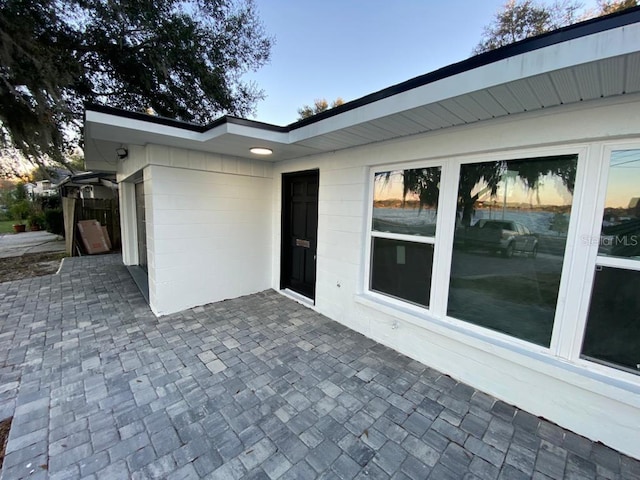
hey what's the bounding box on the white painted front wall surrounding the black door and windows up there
[271,96,640,458]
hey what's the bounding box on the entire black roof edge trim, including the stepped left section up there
[85,6,640,133]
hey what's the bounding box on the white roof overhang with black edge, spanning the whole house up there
[85,7,640,170]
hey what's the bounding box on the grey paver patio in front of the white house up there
[0,255,640,480]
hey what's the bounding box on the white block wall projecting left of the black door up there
[117,145,273,315]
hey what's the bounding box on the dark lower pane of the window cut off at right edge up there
[582,267,640,373]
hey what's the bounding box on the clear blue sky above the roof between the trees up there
[245,0,595,125]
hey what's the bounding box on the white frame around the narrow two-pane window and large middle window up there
[361,143,593,354]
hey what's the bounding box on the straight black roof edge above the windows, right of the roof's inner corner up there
[289,7,640,130]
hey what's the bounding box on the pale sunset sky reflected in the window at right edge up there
[606,150,640,208]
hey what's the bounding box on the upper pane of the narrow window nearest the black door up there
[372,167,440,236]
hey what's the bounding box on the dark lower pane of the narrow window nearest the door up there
[371,237,433,307]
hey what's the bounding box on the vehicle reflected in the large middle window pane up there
[456,219,538,258]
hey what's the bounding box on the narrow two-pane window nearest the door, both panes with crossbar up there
[369,167,440,307]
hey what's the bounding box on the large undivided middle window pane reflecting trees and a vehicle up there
[447,155,577,346]
